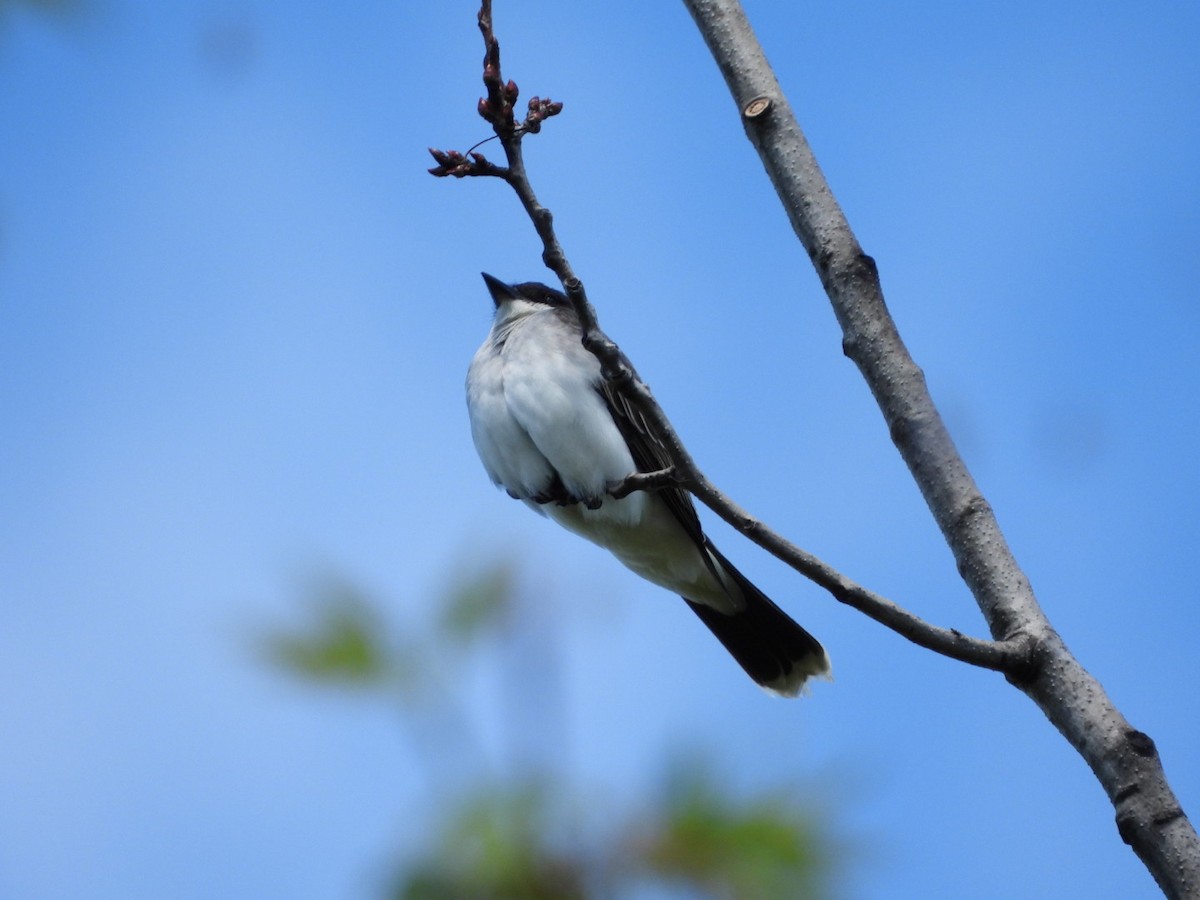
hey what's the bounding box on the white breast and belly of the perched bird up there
[467,300,738,611]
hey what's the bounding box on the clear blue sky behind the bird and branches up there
[0,0,1200,898]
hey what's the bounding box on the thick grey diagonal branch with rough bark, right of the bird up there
[684,0,1200,898]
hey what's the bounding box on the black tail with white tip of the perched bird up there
[684,540,829,697]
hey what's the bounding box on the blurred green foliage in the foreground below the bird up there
[264,564,840,900]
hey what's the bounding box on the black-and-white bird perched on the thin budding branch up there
[467,272,830,697]
